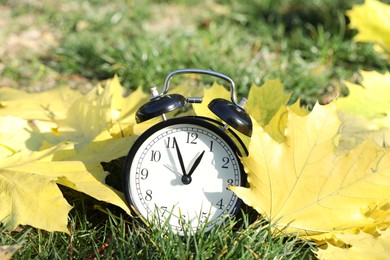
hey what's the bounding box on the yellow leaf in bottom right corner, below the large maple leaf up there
[316,229,390,260]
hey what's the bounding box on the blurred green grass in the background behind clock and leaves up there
[0,0,390,106]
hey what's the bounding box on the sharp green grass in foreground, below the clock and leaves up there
[0,191,314,259]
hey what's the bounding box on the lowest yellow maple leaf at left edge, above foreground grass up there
[0,145,72,232]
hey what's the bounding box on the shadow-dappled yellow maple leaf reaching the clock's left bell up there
[0,76,150,146]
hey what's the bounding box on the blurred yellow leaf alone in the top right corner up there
[347,0,390,54]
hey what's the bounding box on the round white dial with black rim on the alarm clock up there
[125,119,242,234]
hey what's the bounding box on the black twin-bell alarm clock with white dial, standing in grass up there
[123,69,252,235]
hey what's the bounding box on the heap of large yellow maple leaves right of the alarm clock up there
[234,69,390,258]
